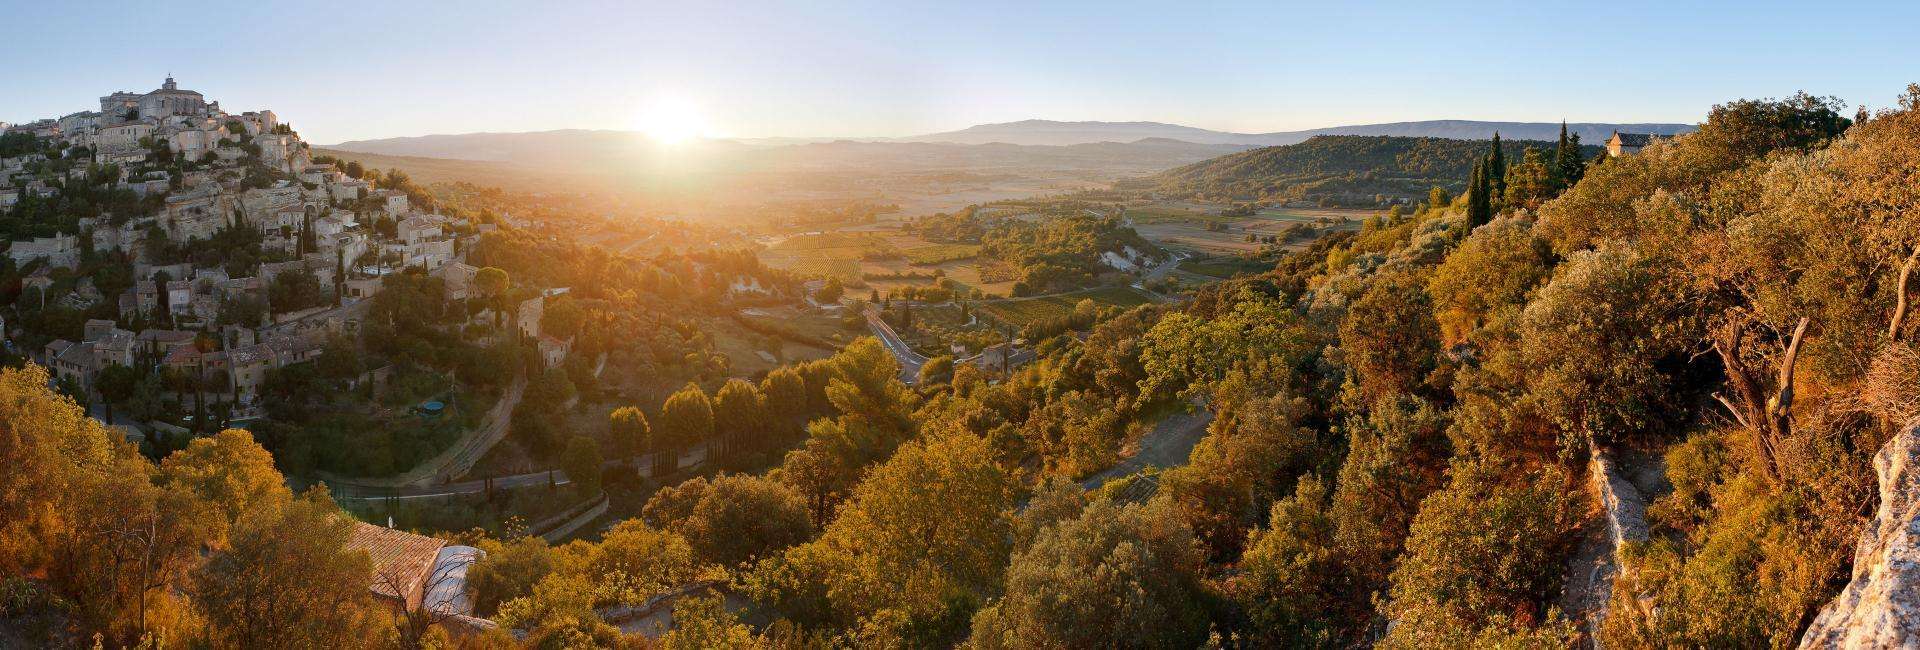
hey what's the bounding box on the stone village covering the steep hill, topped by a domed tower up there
[0,77,564,435]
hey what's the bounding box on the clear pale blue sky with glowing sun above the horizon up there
[0,0,1920,144]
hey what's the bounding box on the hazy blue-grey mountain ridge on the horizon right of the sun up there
[895,119,1693,146]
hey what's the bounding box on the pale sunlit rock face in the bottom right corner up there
[1801,426,1920,648]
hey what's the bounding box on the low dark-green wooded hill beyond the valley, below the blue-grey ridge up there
[1117,136,1599,207]
